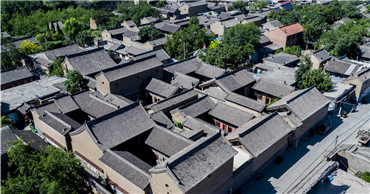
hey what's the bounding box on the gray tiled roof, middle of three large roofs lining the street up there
[238,112,292,157]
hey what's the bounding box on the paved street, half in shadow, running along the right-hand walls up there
[241,105,370,193]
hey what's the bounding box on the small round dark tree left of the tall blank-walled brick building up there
[64,70,86,94]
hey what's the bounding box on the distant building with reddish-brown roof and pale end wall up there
[265,23,303,48]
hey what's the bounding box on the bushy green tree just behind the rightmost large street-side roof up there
[302,69,332,92]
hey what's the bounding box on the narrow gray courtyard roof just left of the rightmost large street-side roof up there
[225,92,266,112]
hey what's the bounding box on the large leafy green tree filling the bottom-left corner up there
[1,139,84,193]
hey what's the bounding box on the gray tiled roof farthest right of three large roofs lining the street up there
[267,87,329,121]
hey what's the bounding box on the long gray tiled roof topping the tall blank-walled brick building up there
[102,55,162,81]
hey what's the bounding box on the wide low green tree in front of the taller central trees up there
[201,43,254,69]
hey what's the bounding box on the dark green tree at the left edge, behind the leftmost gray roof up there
[0,43,23,70]
